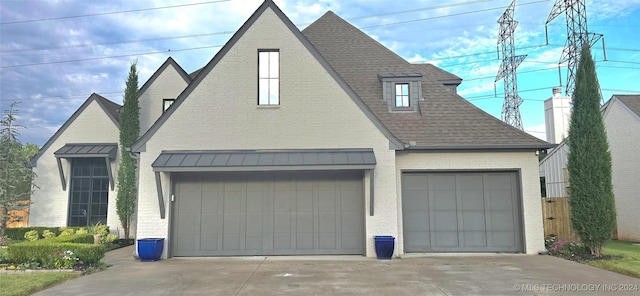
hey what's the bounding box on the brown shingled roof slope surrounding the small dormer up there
[302,11,554,149]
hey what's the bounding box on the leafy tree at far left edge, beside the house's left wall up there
[0,102,38,235]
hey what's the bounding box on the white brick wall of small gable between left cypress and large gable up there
[138,65,187,135]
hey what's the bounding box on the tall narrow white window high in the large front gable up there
[258,50,280,105]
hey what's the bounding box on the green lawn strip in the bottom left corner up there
[0,272,80,296]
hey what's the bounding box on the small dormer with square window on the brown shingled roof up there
[378,73,422,112]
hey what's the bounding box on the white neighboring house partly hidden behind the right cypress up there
[540,95,640,241]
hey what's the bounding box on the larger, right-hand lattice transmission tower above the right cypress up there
[545,0,607,97]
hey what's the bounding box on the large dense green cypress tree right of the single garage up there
[567,46,616,257]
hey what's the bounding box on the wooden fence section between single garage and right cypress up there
[542,197,578,240]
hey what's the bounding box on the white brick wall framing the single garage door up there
[396,151,544,254]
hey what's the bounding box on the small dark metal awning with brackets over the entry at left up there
[53,143,118,191]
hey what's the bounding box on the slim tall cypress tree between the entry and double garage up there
[116,62,140,238]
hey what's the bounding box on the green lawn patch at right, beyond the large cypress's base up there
[587,241,640,278]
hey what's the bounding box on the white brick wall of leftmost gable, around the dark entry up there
[29,101,121,233]
